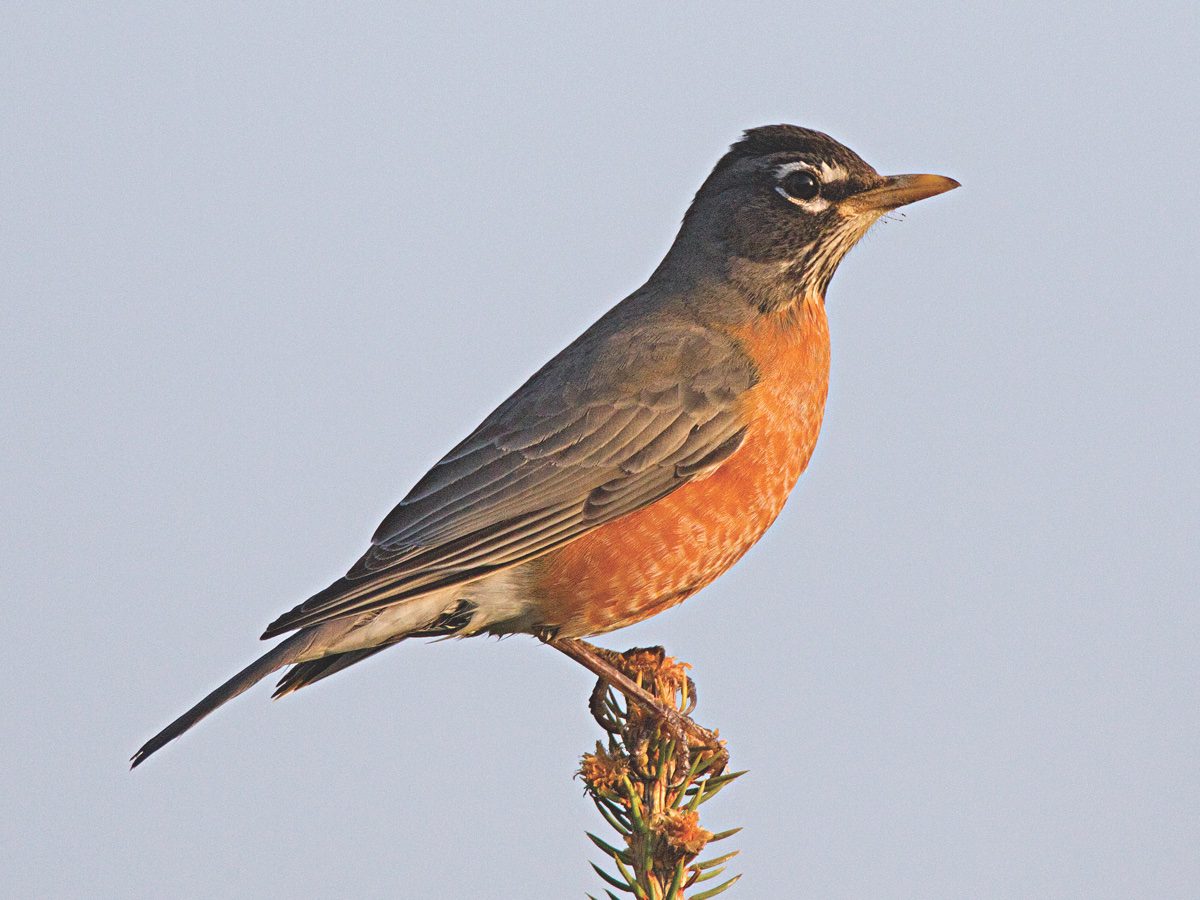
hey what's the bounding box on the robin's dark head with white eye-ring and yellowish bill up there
[668,125,958,311]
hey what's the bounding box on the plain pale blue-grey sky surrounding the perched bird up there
[0,1,1200,898]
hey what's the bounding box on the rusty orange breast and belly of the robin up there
[532,301,829,637]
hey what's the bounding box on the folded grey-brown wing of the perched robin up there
[264,322,755,637]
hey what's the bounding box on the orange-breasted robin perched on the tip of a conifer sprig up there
[132,125,959,767]
